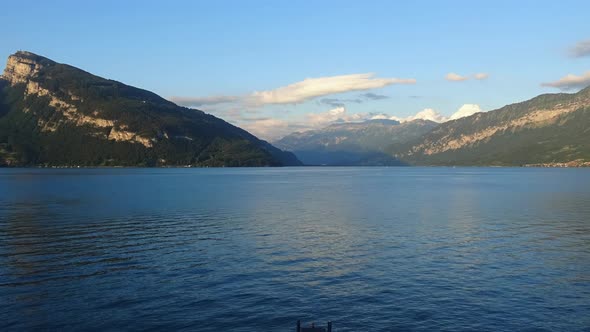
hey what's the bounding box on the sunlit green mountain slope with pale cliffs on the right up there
[394,87,590,166]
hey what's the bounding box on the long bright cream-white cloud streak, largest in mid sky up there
[249,73,416,105]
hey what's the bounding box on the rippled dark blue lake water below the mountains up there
[0,167,590,331]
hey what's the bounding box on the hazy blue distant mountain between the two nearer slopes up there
[274,120,438,166]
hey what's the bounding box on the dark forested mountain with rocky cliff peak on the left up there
[0,51,301,166]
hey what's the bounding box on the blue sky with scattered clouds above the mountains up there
[0,0,590,139]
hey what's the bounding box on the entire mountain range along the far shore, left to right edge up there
[0,51,590,167]
